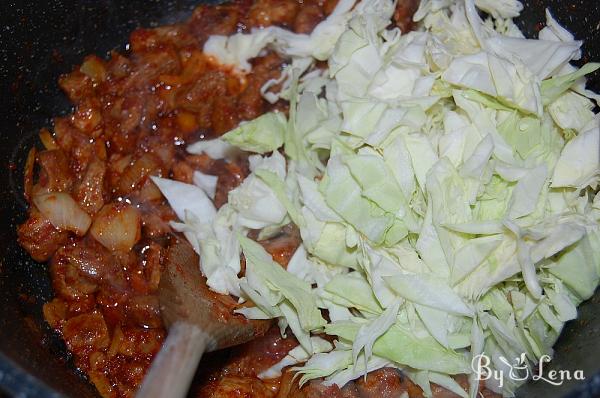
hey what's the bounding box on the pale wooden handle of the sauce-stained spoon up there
[136,322,213,398]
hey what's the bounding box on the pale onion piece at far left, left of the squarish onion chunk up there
[33,192,92,236]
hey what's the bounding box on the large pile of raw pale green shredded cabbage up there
[154,0,600,397]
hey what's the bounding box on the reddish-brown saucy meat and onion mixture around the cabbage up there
[18,0,496,398]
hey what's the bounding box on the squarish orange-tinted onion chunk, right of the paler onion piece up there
[90,202,141,251]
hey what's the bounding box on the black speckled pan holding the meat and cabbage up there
[0,0,600,398]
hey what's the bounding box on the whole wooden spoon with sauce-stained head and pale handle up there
[136,240,271,398]
